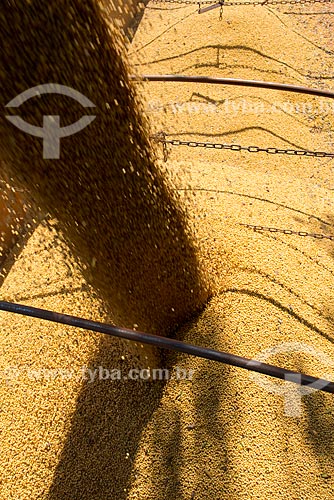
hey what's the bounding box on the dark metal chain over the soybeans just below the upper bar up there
[152,136,334,161]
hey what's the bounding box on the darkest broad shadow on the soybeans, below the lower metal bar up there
[48,341,163,500]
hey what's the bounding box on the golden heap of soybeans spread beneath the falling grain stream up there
[0,0,334,500]
